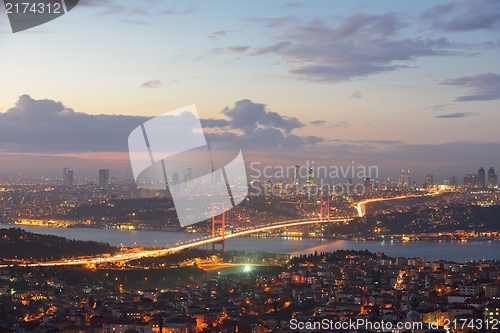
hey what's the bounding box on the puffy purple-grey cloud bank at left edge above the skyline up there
[0,95,149,152]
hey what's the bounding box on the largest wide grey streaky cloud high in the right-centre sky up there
[217,13,494,82]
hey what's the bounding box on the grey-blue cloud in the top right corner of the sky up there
[421,0,500,32]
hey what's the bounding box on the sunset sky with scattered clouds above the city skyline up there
[0,0,500,182]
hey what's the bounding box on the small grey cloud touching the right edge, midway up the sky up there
[441,72,500,102]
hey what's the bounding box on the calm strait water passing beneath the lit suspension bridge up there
[0,224,500,262]
